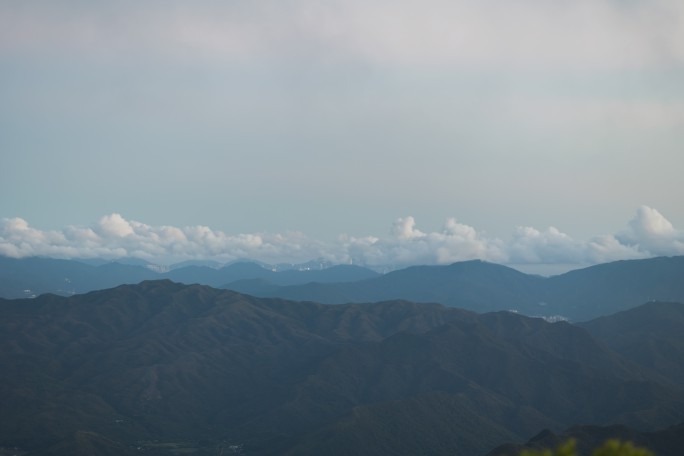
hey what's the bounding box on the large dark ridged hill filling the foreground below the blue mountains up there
[0,281,684,456]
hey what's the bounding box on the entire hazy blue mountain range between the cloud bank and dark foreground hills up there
[0,256,684,322]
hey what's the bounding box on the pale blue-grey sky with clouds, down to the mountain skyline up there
[0,0,684,271]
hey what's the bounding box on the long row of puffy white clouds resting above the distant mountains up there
[0,206,684,267]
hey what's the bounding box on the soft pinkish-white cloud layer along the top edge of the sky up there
[0,0,684,69]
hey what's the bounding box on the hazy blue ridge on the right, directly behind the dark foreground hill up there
[226,256,684,321]
